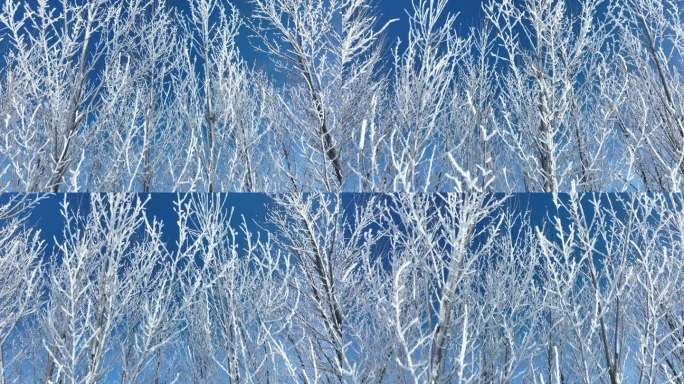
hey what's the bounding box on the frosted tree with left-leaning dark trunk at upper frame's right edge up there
[612,0,684,191]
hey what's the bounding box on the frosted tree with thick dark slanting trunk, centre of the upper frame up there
[252,0,387,191]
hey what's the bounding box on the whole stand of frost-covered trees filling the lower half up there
[0,193,684,383]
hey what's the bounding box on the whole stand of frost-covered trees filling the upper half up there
[0,0,684,192]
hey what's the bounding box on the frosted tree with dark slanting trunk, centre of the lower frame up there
[271,194,386,383]
